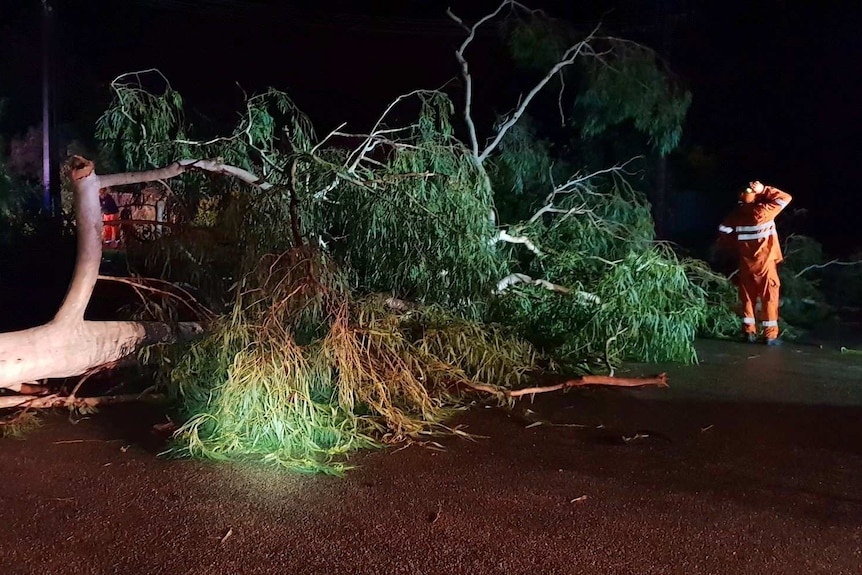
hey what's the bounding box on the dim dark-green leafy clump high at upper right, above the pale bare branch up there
[577,43,691,154]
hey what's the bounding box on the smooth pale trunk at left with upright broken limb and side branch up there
[0,156,271,391]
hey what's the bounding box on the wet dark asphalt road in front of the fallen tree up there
[0,341,862,575]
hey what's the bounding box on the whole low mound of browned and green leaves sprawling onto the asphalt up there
[170,251,537,474]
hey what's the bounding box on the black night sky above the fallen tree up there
[0,0,862,253]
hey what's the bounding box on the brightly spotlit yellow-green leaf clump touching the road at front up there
[173,323,371,473]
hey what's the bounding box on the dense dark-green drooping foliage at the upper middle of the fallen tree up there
[329,95,505,310]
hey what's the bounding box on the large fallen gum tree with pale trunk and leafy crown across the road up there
[0,0,724,472]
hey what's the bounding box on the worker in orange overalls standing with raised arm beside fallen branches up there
[718,180,792,345]
